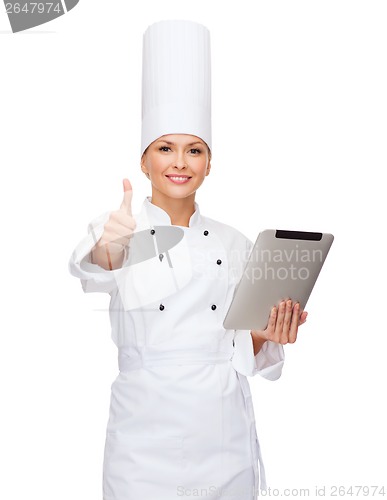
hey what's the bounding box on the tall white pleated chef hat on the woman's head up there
[141,20,211,155]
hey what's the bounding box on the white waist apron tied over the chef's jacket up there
[103,344,266,500]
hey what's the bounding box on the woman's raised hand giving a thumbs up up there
[92,179,136,270]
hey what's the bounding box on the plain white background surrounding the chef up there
[0,0,387,500]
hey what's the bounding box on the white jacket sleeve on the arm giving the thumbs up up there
[68,212,126,293]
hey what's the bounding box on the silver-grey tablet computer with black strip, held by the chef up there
[223,229,333,330]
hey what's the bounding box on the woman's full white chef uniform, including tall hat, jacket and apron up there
[69,21,284,500]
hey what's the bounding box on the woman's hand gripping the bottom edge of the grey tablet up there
[251,299,308,351]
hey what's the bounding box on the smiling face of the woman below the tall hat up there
[141,134,211,198]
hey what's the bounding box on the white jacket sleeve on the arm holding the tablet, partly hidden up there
[232,234,285,380]
